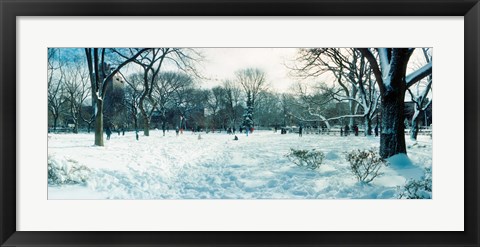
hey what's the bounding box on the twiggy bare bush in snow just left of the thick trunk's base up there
[346,149,386,184]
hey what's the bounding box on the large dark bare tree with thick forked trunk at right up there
[358,48,432,158]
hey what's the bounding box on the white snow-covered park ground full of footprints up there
[48,130,432,199]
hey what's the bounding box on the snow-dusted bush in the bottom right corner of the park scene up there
[398,168,432,199]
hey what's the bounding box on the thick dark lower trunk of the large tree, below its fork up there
[380,90,407,158]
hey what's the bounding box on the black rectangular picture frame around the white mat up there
[0,0,480,246]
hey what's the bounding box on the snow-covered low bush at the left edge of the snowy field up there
[47,155,91,185]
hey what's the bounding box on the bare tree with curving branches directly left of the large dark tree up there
[293,48,380,135]
